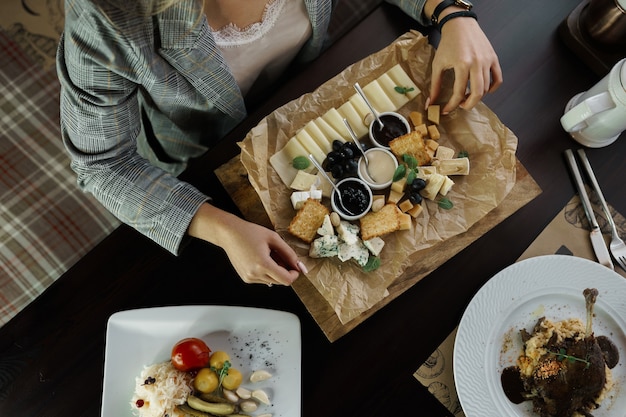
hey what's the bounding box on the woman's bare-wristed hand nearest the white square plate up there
[189,203,306,285]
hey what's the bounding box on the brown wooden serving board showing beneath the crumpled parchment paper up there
[215,156,541,342]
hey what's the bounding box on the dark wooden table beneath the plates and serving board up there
[0,0,626,417]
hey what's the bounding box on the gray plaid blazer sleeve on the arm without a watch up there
[57,10,207,254]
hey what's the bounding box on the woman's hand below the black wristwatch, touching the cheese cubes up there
[428,17,502,114]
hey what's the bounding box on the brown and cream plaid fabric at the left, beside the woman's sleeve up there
[0,31,118,325]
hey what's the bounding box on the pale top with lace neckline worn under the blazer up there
[213,0,311,96]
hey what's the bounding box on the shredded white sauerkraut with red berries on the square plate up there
[130,361,192,417]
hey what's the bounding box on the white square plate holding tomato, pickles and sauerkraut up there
[101,306,301,417]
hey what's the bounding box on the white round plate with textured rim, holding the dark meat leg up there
[454,255,626,417]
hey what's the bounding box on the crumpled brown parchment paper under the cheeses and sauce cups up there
[239,32,517,323]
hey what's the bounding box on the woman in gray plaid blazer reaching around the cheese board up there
[57,0,502,285]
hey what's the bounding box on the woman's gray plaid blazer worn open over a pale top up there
[57,0,425,253]
